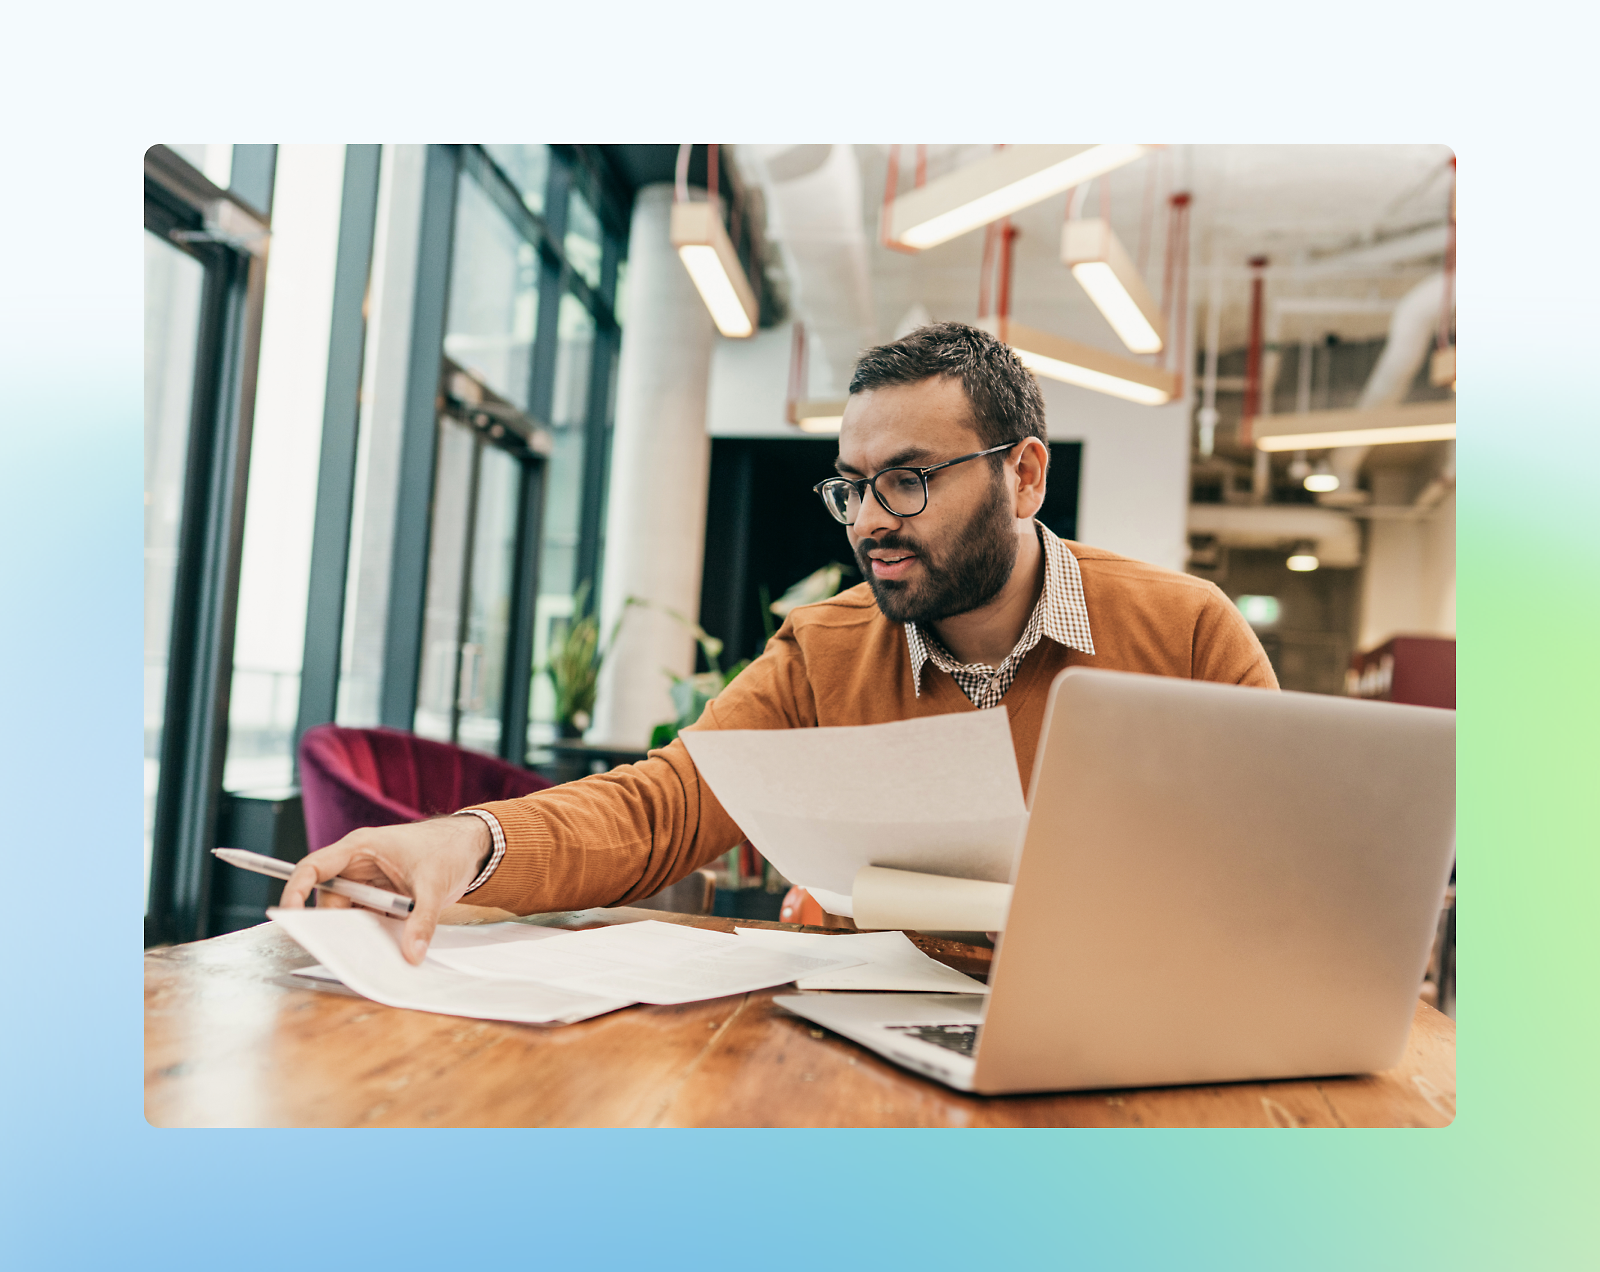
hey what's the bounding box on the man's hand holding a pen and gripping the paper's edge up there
[278,816,493,963]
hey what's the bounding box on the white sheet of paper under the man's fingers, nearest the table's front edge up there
[267,909,635,1024]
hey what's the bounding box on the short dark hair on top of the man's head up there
[850,323,1050,459]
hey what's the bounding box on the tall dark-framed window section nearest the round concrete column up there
[414,146,622,762]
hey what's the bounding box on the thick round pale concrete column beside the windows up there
[590,184,717,746]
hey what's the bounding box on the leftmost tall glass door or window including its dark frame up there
[144,146,266,944]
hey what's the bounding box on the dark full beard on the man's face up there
[856,483,1016,622]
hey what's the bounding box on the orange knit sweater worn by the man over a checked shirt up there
[470,542,1277,914]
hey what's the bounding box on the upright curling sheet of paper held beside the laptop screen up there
[680,707,1027,914]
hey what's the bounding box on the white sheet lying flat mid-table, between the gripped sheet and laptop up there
[430,920,859,1003]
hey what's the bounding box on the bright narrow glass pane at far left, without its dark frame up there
[144,234,205,907]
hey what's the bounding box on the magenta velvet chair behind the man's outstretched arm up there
[299,725,550,850]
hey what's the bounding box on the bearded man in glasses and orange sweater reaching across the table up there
[282,323,1277,963]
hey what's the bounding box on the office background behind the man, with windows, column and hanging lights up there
[144,144,1454,1011]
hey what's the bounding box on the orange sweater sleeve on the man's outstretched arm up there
[460,611,816,914]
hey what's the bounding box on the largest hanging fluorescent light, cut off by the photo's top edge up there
[883,146,1150,251]
